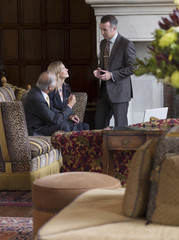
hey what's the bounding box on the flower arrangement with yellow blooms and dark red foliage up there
[134,0,179,89]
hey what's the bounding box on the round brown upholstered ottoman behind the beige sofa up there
[32,172,121,234]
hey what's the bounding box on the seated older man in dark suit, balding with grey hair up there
[24,72,89,136]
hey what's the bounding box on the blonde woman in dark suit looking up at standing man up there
[47,61,89,132]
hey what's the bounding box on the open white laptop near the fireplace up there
[143,107,168,122]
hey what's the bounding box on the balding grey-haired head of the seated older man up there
[36,71,56,91]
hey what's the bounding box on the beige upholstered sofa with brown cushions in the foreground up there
[35,127,179,240]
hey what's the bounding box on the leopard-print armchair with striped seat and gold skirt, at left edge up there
[0,86,62,190]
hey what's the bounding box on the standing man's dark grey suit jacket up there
[100,34,136,103]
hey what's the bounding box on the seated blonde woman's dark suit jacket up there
[49,83,71,111]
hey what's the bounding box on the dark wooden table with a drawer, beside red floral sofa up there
[103,128,164,176]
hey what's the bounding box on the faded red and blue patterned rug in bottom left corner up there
[0,217,33,240]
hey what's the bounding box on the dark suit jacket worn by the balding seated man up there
[24,87,72,135]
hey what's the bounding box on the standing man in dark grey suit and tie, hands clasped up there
[93,15,136,129]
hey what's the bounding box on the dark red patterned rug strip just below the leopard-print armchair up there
[0,191,33,207]
